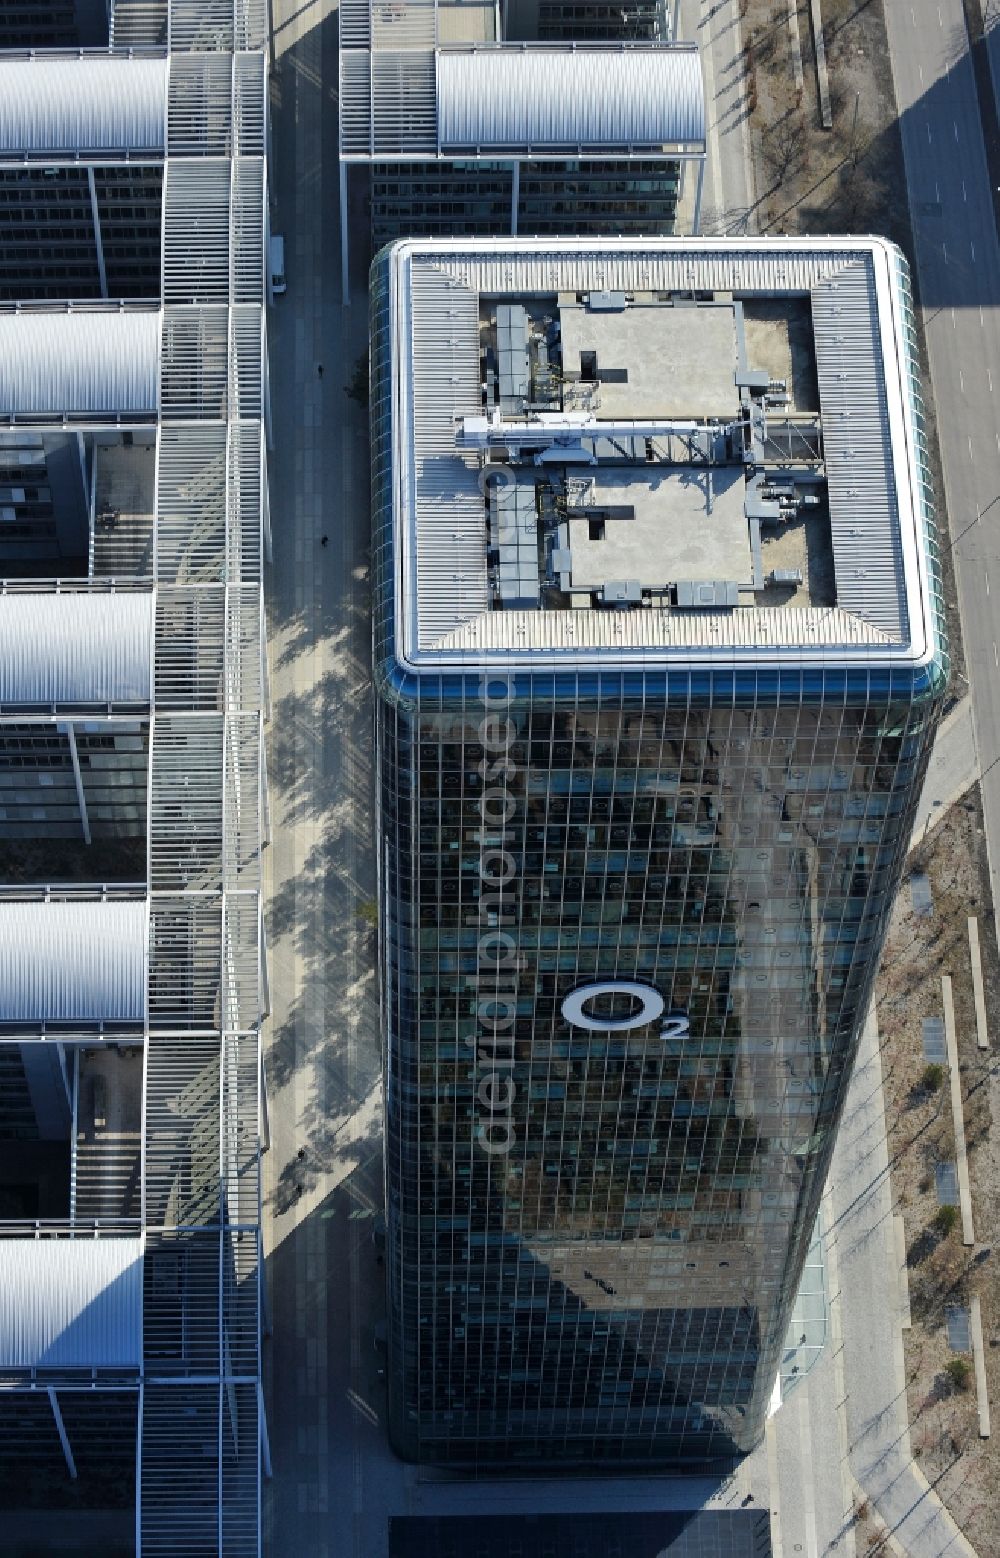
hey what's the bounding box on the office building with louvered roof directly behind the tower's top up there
[338,0,706,288]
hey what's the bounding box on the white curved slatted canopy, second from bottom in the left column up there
[0,899,148,1025]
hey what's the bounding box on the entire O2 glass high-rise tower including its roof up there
[372,238,947,1466]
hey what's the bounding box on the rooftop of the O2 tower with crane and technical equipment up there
[373,238,939,665]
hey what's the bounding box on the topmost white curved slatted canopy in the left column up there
[0,53,168,156]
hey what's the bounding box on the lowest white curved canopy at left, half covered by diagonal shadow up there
[0,1239,142,1369]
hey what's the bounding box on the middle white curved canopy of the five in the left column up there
[0,592,153,707]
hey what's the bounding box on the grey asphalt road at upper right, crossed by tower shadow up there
[885,0,1000,947]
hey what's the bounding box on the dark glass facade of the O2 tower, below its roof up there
[372,236,947,1466]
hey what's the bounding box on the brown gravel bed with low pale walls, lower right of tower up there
[877,785,1000,1558]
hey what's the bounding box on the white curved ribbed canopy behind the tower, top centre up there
[436,45,706,151]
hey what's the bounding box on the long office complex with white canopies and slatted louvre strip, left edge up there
[0,0,268,1558]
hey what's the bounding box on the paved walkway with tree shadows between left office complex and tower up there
[265,0,385,1558]
